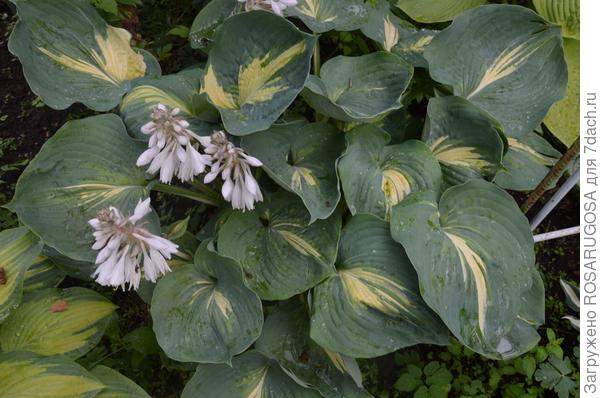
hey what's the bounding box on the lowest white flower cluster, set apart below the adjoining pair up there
[89,198,178,290]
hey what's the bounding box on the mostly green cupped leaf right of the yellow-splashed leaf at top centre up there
[302,51,413,121]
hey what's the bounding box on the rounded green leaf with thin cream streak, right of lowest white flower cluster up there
[151,244,263,363]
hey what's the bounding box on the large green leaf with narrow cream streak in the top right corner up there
[425,4,567,136]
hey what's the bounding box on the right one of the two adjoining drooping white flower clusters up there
[200,131,263,211]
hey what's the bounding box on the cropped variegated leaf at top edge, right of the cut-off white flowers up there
[285,0,368,33]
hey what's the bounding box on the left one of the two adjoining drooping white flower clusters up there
[136,104,210,184]
